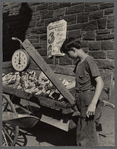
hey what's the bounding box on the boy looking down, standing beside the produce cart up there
[61,38,104,146]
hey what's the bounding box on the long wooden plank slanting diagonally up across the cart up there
[22,39,77,111]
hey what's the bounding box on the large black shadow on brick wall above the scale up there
[3,3,32,61]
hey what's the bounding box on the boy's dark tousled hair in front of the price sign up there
[60,37,81,53]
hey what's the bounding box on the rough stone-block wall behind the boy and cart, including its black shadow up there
[3,2,114,77]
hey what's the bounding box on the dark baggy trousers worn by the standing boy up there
[75,91,101,147]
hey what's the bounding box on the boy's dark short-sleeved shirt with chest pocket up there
[74,56,100,91]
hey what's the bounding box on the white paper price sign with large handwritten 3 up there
[47,20,67,58]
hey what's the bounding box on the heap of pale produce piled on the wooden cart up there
[2,71,69,101]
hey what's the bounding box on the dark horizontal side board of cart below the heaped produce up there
[2,84,73,114]
